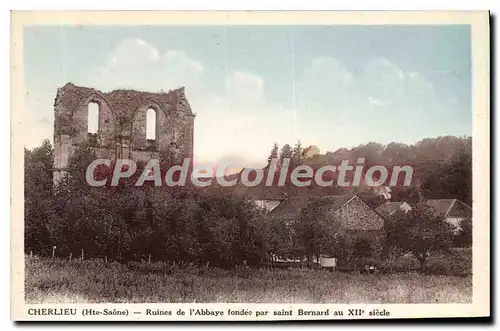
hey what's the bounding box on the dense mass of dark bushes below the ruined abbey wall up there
[25,188,267,266]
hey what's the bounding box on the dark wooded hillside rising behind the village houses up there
[262,136,472,207]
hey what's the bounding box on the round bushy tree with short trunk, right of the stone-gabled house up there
[386,205,454,271]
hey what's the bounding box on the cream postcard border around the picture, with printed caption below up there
[11,11,490,321]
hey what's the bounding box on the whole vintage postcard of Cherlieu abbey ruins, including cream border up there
[11,11,490,321]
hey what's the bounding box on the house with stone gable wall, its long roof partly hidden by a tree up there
[270,195,384,232]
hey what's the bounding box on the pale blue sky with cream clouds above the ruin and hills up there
[23,25,472,166]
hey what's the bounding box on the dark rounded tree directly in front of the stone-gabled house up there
[293,199,340,268]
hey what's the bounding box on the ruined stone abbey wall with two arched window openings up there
[54,83,195,184]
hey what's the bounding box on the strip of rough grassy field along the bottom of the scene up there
[25,258,472,303]
